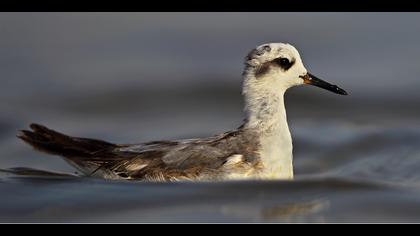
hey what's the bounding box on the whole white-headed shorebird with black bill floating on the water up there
[18,43,347,181]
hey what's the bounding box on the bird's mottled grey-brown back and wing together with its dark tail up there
[18,124,259,181]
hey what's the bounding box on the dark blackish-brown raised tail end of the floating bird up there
[17,124,117,161]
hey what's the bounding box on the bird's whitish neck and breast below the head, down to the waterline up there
[243,72,293,179]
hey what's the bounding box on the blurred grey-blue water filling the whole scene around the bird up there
[0,13,420,222]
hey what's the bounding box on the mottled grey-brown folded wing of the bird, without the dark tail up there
[110,130,258,181]
